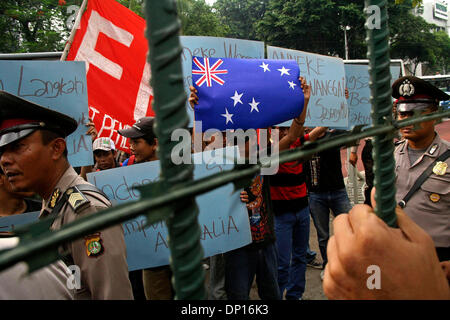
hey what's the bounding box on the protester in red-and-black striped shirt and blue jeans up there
[270,125,310,300]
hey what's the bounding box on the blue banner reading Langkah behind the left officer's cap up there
[0,60,94,167]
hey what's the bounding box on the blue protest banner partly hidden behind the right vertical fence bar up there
[345,64,400,129]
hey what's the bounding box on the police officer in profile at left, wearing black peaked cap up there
[0,91,133,299]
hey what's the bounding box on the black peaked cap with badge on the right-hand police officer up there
[392,76,450,112]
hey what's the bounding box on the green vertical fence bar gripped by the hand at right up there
[365,0,397,227]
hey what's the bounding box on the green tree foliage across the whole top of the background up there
[0,0,450,72]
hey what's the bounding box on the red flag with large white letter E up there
[67,0,154,151]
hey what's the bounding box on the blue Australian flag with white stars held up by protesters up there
[192,57,304,131]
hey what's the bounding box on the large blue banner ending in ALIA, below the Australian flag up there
[88,150,251,271]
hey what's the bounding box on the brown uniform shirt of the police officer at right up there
[394,134,450,247]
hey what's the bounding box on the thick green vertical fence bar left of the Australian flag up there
[145,0,205,300]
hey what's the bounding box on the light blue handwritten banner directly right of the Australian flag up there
[267,46,348,128]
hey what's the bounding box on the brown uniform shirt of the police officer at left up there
[41,167,133,300]
